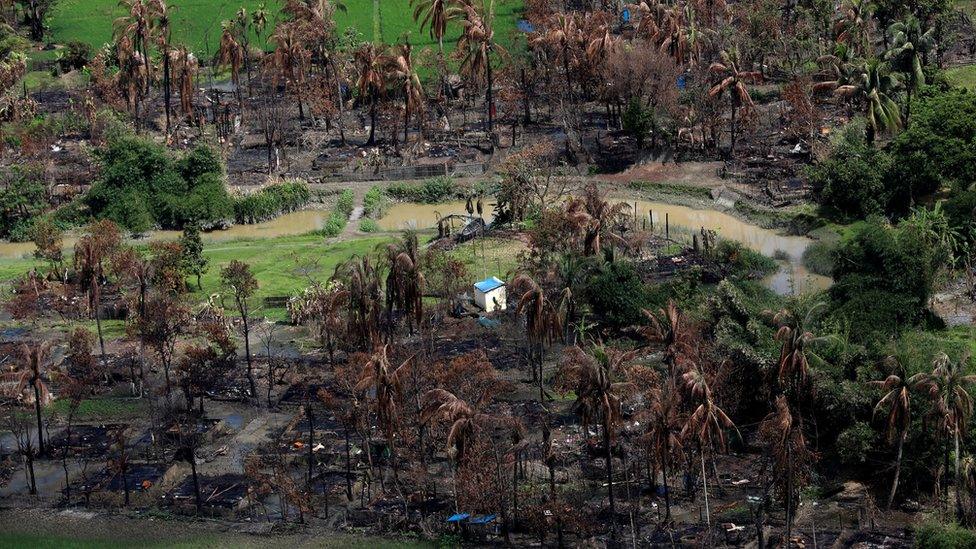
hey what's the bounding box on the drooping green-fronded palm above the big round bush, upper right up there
[834,59,901,142]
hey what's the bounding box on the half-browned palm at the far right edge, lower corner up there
[921,353,976,518]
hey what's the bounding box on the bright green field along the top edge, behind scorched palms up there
[49,0,522,57]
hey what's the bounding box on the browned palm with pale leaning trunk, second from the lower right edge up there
[868,356,925,509]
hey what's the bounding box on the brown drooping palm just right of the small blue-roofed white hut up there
[511,274,562,400]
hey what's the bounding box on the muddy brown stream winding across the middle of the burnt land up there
[0,200,830,294]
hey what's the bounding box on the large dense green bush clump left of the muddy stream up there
[85,137,234,231]
